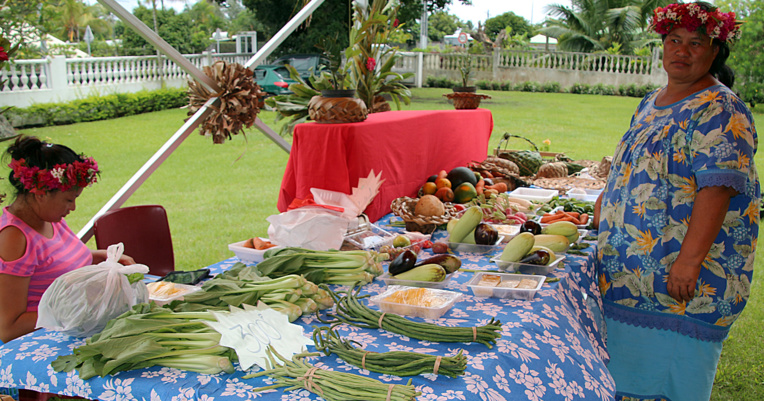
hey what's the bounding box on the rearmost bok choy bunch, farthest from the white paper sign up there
[256,247,384,285]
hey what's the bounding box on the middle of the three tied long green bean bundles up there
[313,327,467,377]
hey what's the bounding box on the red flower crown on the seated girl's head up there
[8,157,100,195]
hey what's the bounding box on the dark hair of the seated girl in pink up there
[5,135,84,196]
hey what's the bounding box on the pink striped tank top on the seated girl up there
[0,207,93,311]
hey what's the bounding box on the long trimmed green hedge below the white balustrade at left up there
[5,88,188,128]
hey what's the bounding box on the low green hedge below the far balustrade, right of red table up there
[425,77,658,98]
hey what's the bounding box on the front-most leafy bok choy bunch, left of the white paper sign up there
[51,303,237,380]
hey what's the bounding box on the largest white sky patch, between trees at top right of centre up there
[448,0,570,28]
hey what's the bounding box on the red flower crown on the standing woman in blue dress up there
[650,3,740,42]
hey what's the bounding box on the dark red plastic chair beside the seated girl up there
[93,205,175,276]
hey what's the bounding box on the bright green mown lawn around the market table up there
[0,89,764,401]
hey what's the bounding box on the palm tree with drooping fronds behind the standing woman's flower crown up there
[539,0,672,54]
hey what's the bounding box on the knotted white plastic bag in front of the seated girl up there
[37,242,149,337]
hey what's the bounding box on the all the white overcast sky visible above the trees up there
[97,0,570,27]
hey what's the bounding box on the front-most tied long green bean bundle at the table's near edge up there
[243,346,421,401]
